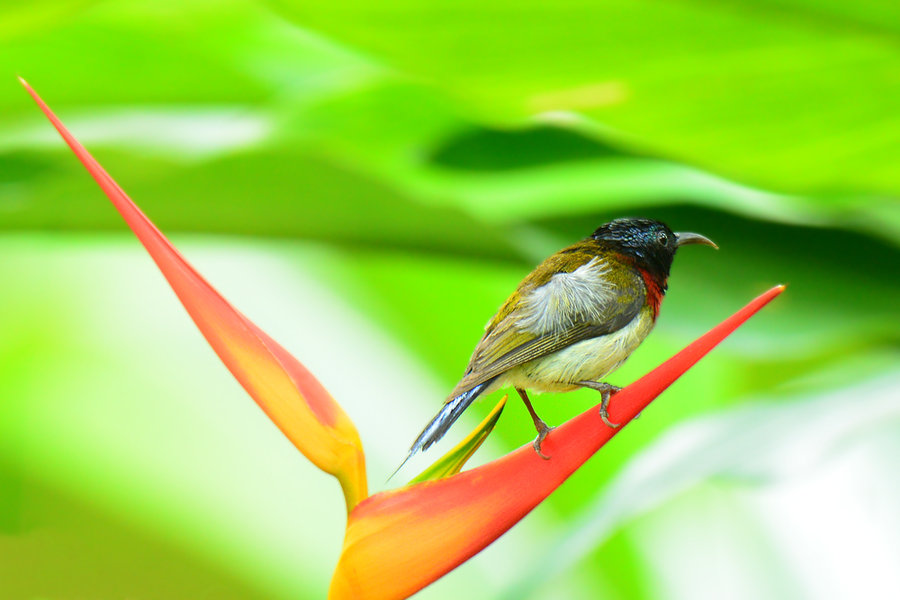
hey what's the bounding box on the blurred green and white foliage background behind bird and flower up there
[0,0,900,600]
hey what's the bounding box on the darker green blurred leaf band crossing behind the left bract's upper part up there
[0,147,516,258]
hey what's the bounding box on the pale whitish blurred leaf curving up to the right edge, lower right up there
[506,368,900,599]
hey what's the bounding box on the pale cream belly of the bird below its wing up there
[500,310,654,392]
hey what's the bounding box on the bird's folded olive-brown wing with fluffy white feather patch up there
[450,257,646,397]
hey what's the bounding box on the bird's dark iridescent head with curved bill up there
[591,218,718,285]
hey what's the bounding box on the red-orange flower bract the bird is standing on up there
[329,286,784,600]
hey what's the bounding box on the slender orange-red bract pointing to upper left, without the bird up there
[20,78,368,511]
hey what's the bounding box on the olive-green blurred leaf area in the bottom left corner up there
[0,476,271,600]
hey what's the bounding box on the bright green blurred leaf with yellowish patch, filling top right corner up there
[275,0,900,194]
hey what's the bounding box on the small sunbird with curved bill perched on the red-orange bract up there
[395,218,718,473]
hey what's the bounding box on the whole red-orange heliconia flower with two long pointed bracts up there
[20,79,784,600]
